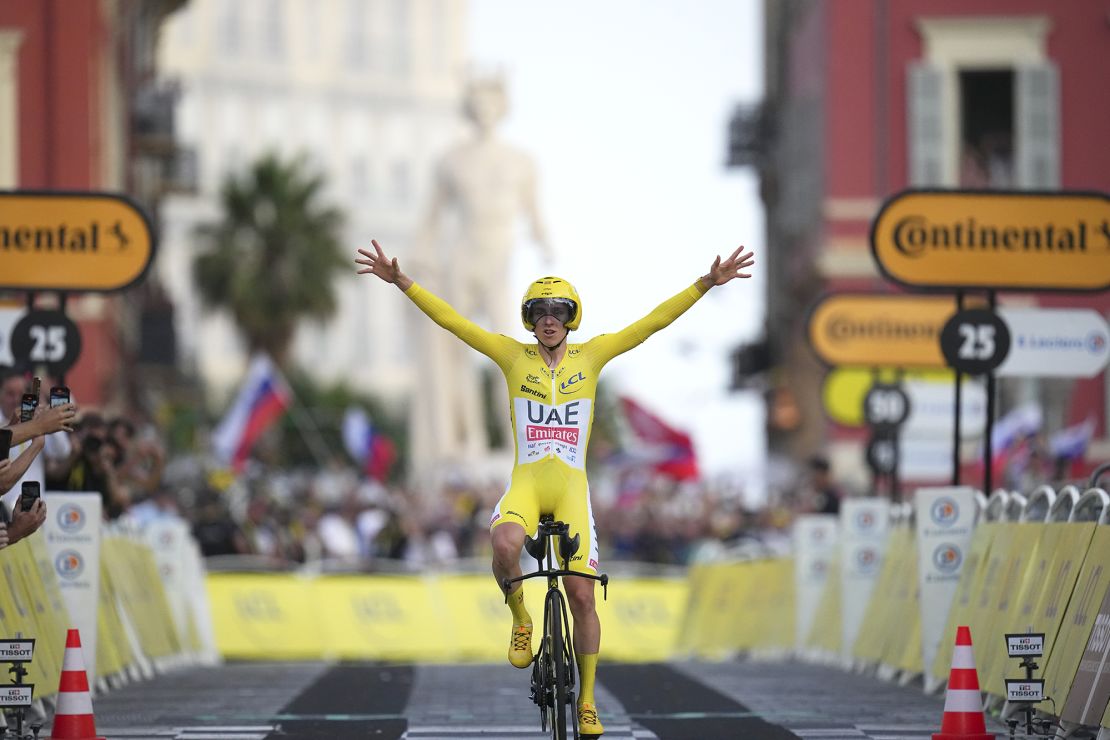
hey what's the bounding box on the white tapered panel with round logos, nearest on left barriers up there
[42,491,101,683]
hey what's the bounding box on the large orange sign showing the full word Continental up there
[871,190,1110,291]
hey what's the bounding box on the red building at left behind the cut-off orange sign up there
[0,0,184,406]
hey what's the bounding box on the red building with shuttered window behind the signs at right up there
[733,0,1110,497]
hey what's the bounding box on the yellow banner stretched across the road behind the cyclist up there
[208,574,688,662]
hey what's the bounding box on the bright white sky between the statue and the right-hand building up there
[468,0,766,503]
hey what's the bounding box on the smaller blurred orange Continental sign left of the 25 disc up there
[809,293,956,367]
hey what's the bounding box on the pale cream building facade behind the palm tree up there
[158,0,466,408]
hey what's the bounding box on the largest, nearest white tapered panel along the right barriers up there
[914,486,976,689]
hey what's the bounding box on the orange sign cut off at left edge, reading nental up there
[0,191,154,293]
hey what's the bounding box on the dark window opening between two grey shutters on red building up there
[958,70,1013,189]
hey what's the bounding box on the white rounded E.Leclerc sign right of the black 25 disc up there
[995,308,1110,377]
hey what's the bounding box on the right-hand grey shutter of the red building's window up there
[1013,63,1060,190]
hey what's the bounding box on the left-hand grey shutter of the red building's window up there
[906,62,944,187]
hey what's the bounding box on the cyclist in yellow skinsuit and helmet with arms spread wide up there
[355,240,755,737]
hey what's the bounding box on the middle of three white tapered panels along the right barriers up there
[840,498,890,658]
